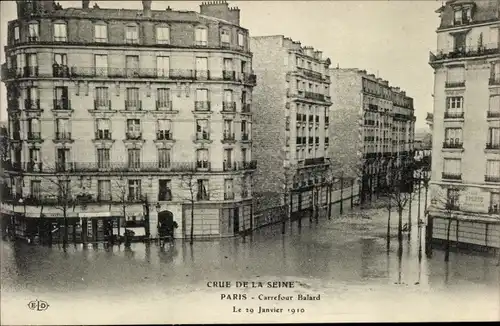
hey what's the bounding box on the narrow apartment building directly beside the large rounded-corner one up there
[250,35,331,224]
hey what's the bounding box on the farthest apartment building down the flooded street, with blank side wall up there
[329,68,416,201]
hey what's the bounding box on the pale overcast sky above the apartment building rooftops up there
[0,0,441,129]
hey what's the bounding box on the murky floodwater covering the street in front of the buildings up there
[1,201,500,324]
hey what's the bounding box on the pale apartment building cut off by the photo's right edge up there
[429,0,500,248]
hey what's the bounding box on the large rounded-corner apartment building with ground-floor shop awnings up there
[2,1,256,242]
